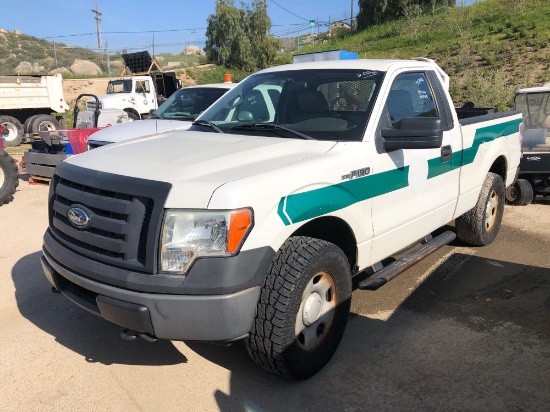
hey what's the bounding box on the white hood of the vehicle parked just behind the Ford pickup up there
[88,119,192,143]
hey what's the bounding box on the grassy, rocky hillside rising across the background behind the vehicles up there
[0,0,550,110]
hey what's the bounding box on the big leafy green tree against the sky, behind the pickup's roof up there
[204,0,279,71]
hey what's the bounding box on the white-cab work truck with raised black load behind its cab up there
[86,52,181,120]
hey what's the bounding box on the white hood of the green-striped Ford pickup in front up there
[66,131,336,208]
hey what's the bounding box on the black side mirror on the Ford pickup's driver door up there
[381,117,443,152]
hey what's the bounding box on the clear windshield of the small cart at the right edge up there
[514,92,550,152]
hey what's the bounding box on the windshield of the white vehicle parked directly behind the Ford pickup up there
[151,87,227,120]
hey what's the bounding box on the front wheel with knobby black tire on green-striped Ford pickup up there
[246,237,352,379]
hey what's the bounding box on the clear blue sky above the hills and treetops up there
[0,0,475,54]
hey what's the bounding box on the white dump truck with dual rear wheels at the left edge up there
[0,74,69,147]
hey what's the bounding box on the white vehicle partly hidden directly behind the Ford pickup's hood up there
[88,82,236,149]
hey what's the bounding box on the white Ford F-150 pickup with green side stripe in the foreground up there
[41,60,522,379]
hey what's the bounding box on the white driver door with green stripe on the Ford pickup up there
[372,71,462,262]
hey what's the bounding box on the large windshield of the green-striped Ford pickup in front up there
[196,69,384,141]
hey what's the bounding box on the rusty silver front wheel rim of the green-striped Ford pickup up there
[296,272,336,351]
